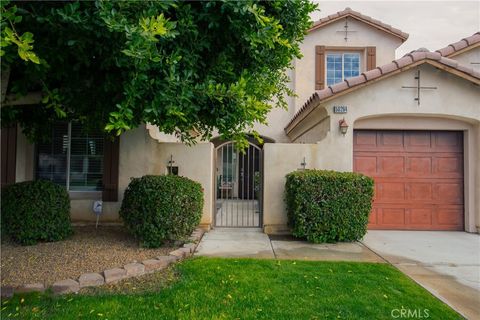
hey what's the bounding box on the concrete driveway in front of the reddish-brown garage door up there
[362,230,480,319]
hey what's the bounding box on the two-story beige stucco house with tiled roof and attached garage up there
[2,8,480,233]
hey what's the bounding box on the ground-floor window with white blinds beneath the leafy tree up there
[36,122,104,191]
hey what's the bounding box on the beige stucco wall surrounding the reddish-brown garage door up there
[291,65,480,232]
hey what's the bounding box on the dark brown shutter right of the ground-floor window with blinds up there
[102,137,120,202]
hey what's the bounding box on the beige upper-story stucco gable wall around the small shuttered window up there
[294,18,402,110]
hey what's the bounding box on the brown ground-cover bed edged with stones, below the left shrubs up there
[1,226,177,286]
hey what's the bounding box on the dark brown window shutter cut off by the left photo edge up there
[1,125,17,188]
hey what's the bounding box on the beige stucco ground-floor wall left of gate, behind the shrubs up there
[16,126,214,225]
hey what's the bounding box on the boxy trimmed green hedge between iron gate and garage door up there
[285,170,374,243]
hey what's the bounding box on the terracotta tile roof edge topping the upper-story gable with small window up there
[308,7,408,41]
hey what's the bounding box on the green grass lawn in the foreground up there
[2,258,461,320]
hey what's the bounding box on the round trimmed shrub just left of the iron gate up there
[120,175,203,248]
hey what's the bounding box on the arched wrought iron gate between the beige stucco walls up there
[215,142,263,227]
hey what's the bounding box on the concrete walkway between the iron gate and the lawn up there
[195,228,385,262]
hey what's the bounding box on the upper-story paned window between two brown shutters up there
[326,53,360,86]
